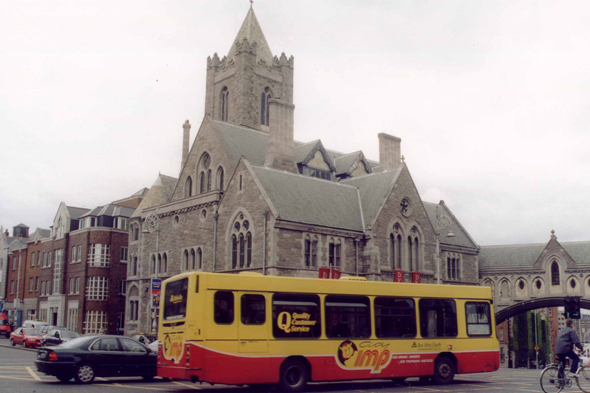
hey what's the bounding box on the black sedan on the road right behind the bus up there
[35,336,157,383]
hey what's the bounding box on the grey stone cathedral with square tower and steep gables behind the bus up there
[125,8,479,335]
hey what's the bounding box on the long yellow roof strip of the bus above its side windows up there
[164,272,492,300]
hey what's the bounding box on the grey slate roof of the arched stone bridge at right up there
[479,237,590,268]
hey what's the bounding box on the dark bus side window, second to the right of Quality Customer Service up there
[375,297,416,338]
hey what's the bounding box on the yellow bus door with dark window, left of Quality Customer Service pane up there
[237,292,271,353]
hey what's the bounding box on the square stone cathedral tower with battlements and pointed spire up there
[205,8,294,132]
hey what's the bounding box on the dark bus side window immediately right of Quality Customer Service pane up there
[326,295,371,338]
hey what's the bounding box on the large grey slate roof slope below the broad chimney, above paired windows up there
[251,165,364,232]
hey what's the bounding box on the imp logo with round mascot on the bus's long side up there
[336,340,391,374]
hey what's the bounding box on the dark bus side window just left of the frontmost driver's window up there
[419,299,457,338]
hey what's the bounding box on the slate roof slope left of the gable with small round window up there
[340,167,403,226]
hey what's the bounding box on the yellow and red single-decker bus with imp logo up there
[158,272,500,391]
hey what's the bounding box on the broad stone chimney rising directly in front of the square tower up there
[264,98,299,173]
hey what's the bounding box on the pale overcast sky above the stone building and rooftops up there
[0,0,590,245]
